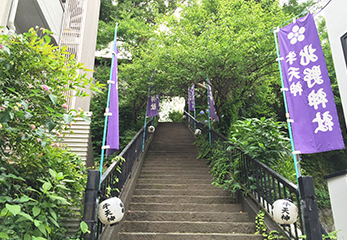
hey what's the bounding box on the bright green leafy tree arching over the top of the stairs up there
[121,0,287,135]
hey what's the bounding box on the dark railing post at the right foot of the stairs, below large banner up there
[298,176,322,240]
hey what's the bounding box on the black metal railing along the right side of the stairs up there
[184,112,304,240]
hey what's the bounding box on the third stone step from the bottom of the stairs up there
[126,211,249,222]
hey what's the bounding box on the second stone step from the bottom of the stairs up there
[122,221,255,233]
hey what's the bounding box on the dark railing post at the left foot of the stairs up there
[83,170,100,240]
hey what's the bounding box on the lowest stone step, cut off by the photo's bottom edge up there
[119,232,263,240]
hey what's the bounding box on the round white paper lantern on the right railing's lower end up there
[272,199,298,224]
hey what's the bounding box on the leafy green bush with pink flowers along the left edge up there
[0,28,102,240]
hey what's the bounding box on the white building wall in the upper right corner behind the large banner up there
[322,0,347,129]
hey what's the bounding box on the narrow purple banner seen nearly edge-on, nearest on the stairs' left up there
[106,43,119,157]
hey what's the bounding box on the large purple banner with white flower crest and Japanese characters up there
[278,14,345,154]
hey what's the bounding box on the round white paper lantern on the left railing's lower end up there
[98,197,125,225]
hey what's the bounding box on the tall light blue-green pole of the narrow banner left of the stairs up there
[99,23,118,190]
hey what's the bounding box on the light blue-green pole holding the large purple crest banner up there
[274,31,301,181]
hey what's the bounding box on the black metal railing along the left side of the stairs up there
[96,120,153,239]
